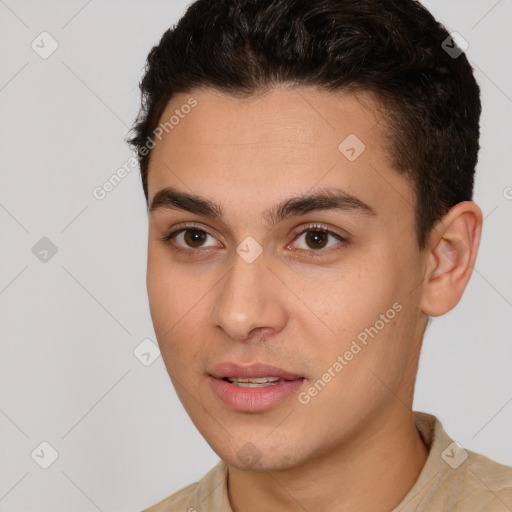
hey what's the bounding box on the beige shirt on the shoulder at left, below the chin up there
[143,461,231,512]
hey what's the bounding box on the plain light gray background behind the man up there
[0,0,512,512]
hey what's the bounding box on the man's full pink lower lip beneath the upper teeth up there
[210,377,304,412]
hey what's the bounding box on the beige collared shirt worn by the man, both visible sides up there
[143,412,512,512]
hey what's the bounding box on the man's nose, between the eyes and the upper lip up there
[212,249,287,341]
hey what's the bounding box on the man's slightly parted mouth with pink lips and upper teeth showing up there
[209,363,306,412]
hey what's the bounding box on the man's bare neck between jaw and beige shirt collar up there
[228,408,428,512]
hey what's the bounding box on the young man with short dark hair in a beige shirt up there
[130,0,512,512]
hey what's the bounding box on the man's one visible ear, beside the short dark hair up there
[421,201,483,316]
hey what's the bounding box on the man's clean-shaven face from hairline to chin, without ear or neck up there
[147,88,426,470]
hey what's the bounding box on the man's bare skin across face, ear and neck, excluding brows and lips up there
[147,87,482,512]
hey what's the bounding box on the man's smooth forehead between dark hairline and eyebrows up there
[148,87,412,224]
